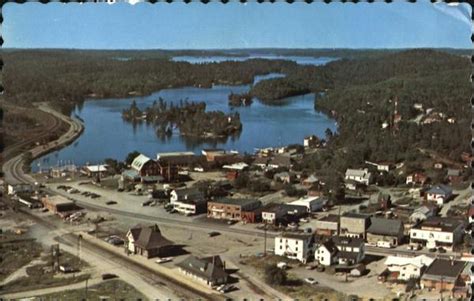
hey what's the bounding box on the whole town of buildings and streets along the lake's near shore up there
[2,130,474,299]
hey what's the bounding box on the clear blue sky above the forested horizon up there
[2,0,472,49]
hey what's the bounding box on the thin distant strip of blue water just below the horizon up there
[172,54,338,66]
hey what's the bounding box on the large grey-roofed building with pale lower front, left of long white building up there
[367,217,404,247]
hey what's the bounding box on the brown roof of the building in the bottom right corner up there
[422,258,466,282]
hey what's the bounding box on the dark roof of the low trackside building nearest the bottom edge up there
[177,255,228,282]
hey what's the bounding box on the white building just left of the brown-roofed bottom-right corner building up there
[385,255,434,281]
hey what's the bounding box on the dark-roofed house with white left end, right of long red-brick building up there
[262,204,308,225]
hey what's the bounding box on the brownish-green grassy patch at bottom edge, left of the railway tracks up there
[34,280,147,301]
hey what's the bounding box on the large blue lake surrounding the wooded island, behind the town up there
[31,63,337,171]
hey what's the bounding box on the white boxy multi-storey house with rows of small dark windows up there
[275,233,313,263]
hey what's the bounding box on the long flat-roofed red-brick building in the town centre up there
[207,198,262,223]
